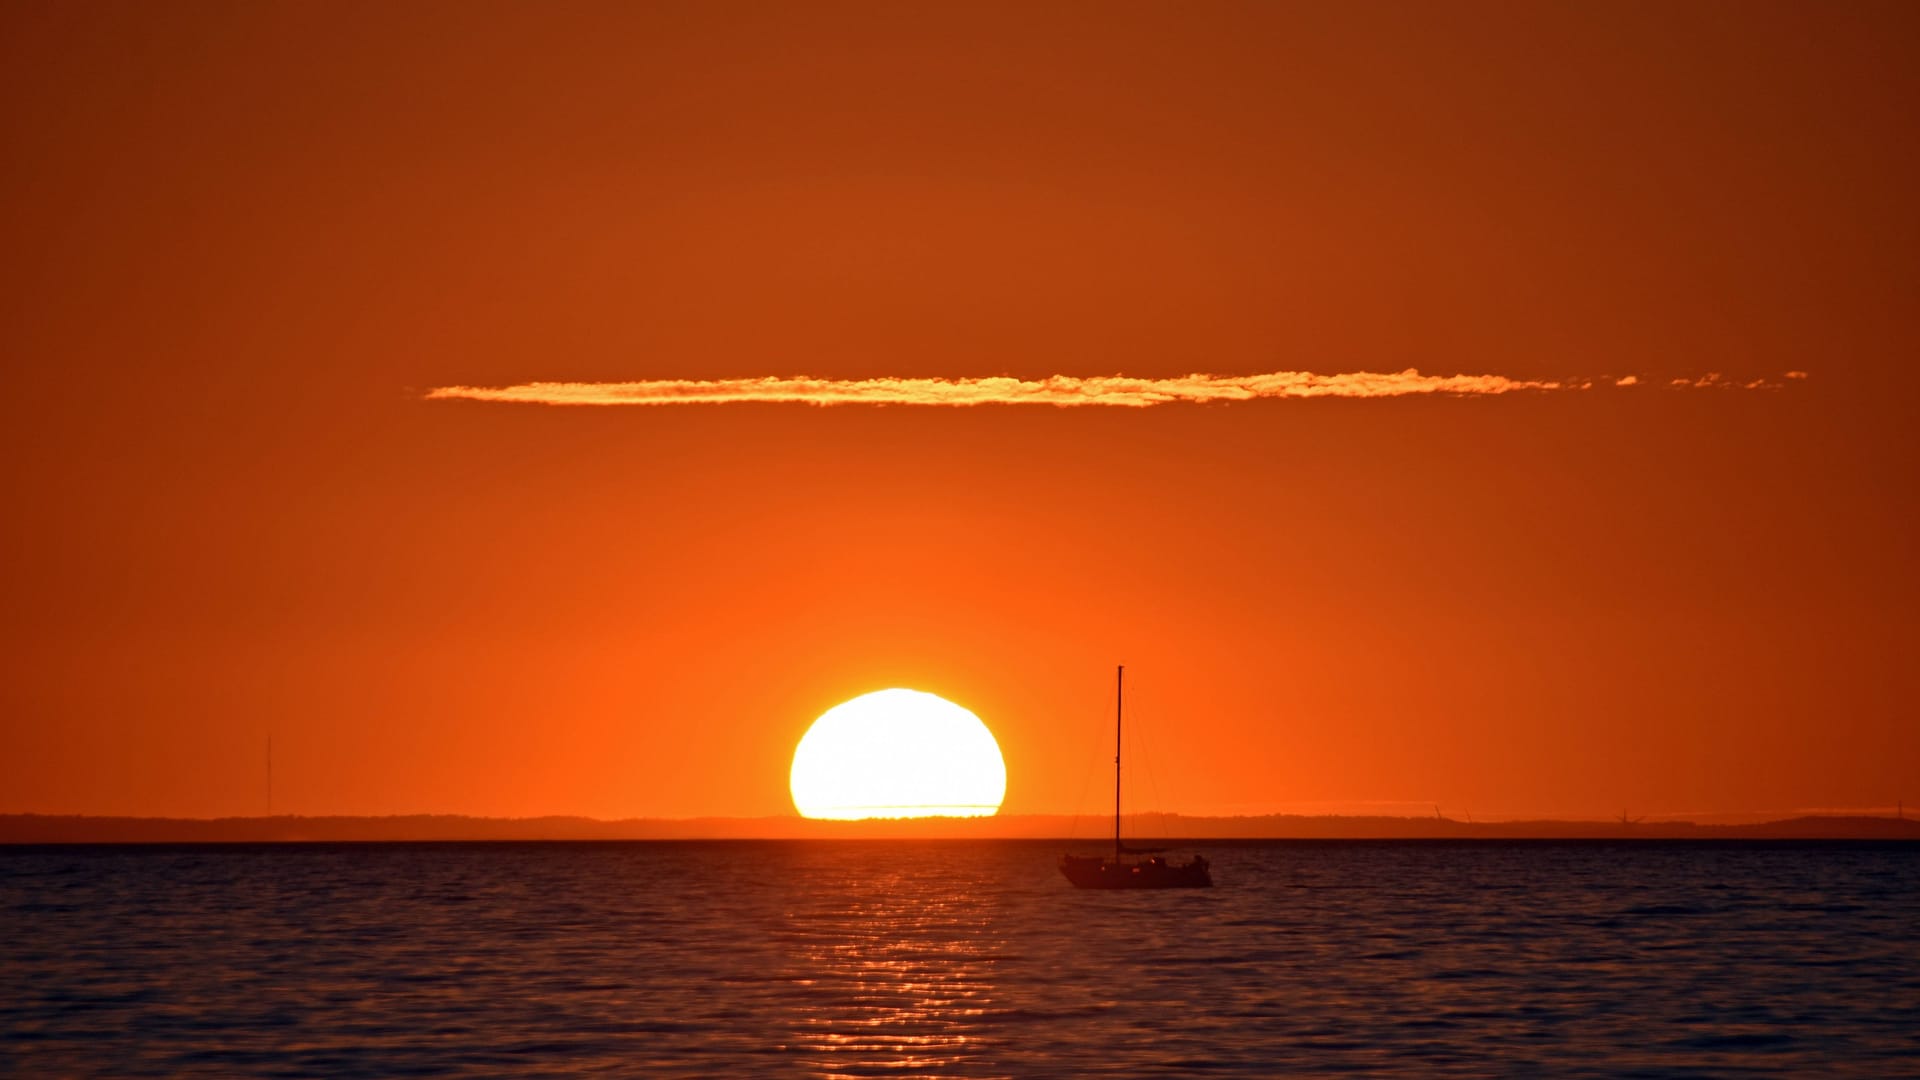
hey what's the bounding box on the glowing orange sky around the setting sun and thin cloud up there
[0,2,1920,817]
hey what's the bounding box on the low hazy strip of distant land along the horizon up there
[0,813,1920,844]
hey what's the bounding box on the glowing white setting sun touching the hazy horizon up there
[791,690,1006,821]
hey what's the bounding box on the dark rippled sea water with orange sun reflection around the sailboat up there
[0,842,1920,1076]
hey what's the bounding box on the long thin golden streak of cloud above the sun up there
[426,367,1805,409]
